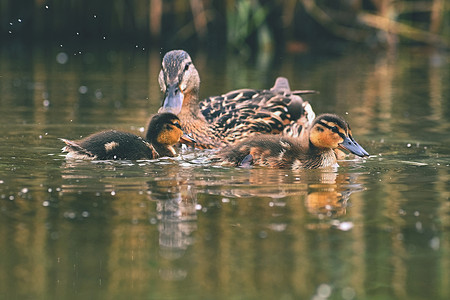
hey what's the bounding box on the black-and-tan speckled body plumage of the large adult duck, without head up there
[200,78,315,143]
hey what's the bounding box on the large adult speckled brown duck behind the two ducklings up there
[158,50,315,148]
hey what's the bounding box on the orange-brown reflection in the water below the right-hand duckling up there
[197,168,364,218]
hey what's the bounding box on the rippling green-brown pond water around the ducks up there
[0,46,450,300]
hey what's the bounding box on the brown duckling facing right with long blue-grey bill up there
[216,114,369,170]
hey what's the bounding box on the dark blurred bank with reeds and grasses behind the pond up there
[0,0,450,53]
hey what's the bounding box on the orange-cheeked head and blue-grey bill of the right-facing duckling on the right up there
[309,114,369,157]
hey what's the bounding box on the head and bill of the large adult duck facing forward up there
[158,50,200,115]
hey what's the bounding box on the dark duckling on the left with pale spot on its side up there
[61,113,194,160]
